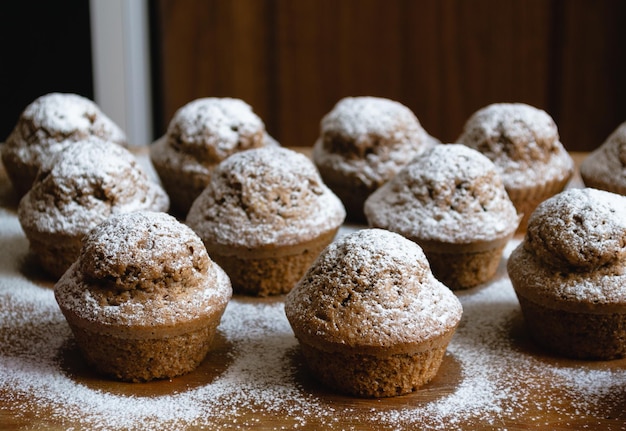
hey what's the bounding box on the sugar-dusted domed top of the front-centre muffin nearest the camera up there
[285,229,462,354]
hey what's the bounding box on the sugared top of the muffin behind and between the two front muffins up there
[187,147,345,247]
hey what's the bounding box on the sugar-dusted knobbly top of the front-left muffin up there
[54,211,232,328]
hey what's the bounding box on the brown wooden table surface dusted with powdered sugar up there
[0,151,626,430]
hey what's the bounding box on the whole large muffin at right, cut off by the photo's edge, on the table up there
[508,189,626,359]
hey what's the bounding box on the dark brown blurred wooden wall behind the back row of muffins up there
[153,0,626,151]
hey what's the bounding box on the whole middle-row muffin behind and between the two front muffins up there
[187,147,346,296]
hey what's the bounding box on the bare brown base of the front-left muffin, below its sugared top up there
[65,313,221,382]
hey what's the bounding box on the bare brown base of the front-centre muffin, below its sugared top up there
[300,343,447,398]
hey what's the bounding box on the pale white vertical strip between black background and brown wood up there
[90,0,152,145]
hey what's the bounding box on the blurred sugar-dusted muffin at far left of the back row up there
[0,93,127,197]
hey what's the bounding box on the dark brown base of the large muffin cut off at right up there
[516,292,626,360]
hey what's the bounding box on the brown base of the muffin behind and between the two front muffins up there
[207,229,338,296]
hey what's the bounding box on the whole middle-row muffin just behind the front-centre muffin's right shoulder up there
[365,144,519,289]
